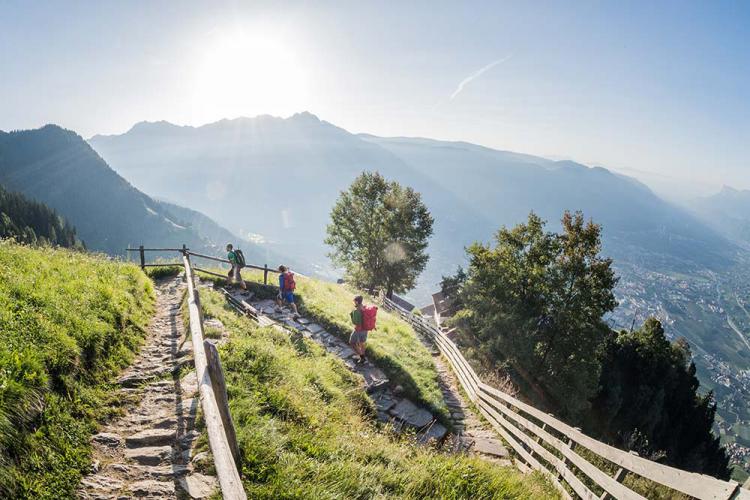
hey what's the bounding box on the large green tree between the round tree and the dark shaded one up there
[458,212,617,417]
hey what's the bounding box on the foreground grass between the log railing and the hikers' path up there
[201,285,557,499]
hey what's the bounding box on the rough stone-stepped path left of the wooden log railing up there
[78,278,218,500]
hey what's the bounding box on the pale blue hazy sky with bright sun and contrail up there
[0,0,750,193]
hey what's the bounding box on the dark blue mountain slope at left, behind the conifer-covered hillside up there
[0,125,266,258]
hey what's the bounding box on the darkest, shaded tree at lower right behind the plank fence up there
[587,318,729,479]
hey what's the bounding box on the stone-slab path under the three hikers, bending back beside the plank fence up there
[226,290,511,465]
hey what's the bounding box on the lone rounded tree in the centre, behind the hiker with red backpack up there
[325,172,433,297]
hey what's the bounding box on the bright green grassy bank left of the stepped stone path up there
[0,242,154,498]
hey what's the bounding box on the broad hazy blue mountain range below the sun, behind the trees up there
[89,113,735,302]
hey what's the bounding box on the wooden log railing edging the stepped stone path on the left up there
[129,247,247,500]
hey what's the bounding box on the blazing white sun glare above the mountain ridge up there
[193,33,309,123]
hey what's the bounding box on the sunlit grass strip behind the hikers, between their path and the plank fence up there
[197,269,449,425]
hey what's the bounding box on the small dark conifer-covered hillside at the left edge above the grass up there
[0,186,84,248]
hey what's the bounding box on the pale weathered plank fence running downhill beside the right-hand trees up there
[383,298,750,500]
